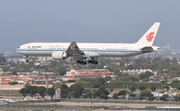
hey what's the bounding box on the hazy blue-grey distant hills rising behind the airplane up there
[0,21,180,52]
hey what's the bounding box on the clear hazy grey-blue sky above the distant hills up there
[0,0,180,28]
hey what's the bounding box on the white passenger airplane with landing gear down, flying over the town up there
[17,22,160,65]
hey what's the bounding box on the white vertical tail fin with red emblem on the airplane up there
[136,22,160,46]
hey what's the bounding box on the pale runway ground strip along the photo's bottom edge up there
[0,101,180,111]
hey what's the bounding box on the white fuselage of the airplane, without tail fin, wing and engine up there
[17,42,158,57]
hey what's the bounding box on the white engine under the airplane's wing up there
[52,51,68,60]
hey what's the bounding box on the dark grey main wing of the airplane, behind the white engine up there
[66,42,84,59]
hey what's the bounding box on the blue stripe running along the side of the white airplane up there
[17,49,142,52]
